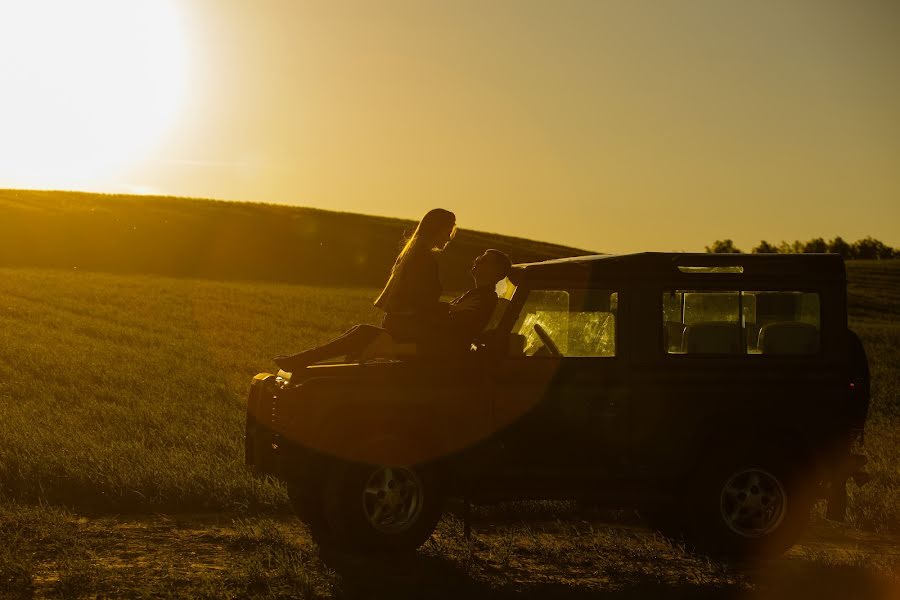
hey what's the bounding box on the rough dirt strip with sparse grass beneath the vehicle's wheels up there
[21,514,900,600]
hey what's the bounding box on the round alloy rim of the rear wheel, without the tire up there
[719,469,787,538]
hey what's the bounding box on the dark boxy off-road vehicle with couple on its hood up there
[246,253,869,555]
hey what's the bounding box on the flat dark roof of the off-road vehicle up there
[513,252,846,283]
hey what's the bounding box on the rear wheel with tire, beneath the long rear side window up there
[688,451,815,559]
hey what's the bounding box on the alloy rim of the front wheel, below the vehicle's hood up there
[362,466,425,534]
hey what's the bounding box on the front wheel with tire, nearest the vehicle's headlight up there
[323,463,443,553]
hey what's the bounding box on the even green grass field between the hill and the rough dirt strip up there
[0,261,900,531]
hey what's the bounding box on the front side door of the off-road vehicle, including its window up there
[487,286,627,479]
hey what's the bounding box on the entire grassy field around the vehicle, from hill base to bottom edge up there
[0,261,900,597]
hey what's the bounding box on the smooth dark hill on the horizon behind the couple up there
[0,190,590,289]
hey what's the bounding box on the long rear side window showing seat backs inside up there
[662,290,820,355]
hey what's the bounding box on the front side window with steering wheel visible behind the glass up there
[513,290,619,356]
